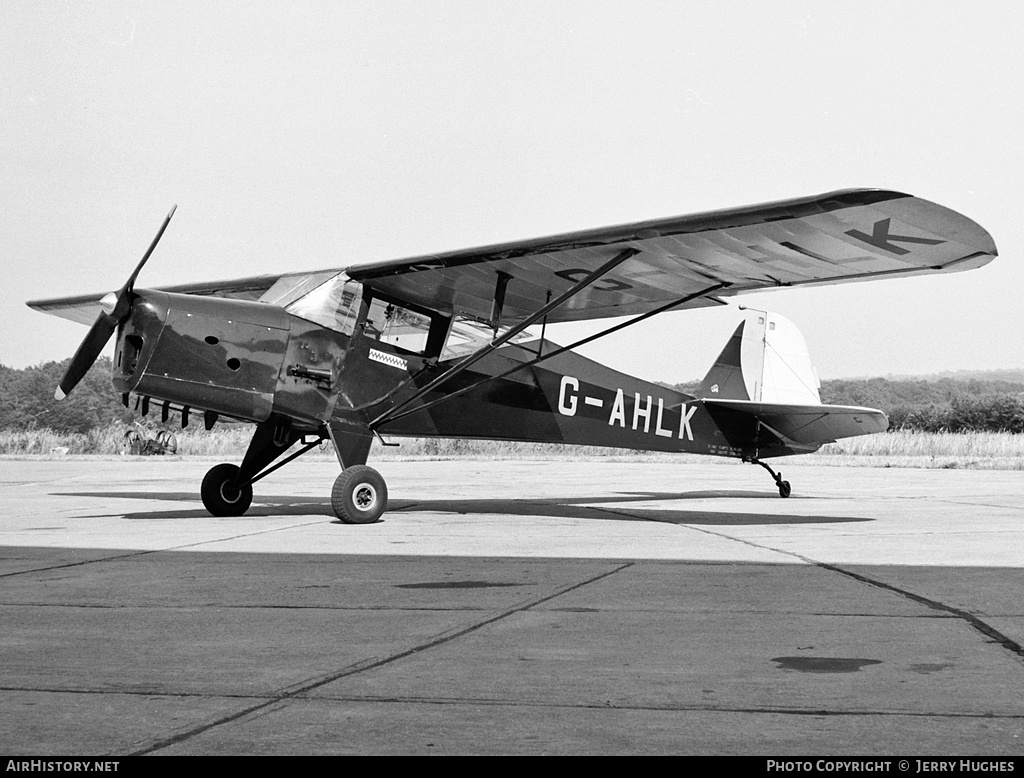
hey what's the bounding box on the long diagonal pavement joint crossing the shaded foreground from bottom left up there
[119,562,635,757]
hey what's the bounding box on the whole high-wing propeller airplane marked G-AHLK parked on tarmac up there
[28,189,996,524]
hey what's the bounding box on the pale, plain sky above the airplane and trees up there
[0,0,1024,382]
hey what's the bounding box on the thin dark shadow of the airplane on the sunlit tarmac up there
[60,490,873,526]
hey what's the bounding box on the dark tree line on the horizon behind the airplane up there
[6,357,1024,433]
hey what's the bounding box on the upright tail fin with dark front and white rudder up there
[698,310,821,405]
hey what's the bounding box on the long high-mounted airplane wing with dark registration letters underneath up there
[28,189,996,325]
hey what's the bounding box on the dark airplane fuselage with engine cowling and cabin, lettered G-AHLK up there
[114,273,806,457]
